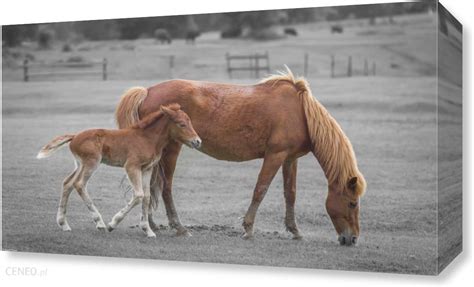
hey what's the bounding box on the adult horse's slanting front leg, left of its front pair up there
[242,152,287,239]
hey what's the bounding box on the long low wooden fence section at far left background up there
[22,58,107,82]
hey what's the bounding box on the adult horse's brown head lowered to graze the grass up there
[326,175,366,248]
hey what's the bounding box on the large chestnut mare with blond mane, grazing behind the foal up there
[116,69,366,245]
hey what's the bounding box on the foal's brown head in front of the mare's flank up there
[161,104,202,148]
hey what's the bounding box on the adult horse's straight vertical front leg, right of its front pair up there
[283,159,302,239]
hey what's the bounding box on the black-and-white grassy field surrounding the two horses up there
[2,3,460,274]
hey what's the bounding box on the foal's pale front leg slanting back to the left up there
[107,166,145,231]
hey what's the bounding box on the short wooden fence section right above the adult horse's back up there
[226,52,270,79]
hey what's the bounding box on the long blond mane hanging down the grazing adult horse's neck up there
[260,66,366,196]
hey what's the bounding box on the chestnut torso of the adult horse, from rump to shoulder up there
[140,80,307,161]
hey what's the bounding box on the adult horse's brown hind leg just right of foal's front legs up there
[152,142,191,236]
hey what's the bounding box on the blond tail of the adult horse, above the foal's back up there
[115,87,148,129]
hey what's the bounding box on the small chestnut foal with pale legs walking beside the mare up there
[37,104,201,237]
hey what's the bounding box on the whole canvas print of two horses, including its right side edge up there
[2,1,462,274]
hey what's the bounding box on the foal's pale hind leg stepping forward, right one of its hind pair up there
[74,159,106,230]
